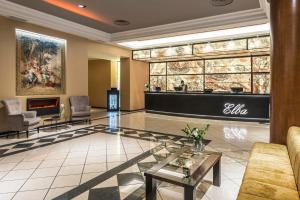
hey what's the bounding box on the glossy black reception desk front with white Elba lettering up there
[145,92,270,122]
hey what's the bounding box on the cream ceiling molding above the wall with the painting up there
[0,0,111,42]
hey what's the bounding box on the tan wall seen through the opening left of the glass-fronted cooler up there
[88,60,111,108]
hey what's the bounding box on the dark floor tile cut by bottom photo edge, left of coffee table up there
[88,187,121,200]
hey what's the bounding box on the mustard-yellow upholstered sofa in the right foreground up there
[237,127,300,200]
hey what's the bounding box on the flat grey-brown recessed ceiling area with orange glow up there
[8,0,260,33]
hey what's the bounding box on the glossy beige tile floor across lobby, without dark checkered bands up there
[0,112,269,200]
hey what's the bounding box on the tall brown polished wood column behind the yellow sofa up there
[270,0,300,144]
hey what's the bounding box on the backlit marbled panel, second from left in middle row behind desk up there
[167,60,204,75]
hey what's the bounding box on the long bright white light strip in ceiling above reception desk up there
[118,23,270,49]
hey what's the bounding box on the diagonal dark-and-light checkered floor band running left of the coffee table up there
[55,141,210,200]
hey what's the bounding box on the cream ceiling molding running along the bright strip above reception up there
[112,8,268,42]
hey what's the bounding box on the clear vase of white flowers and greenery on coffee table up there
[182,124,210,153]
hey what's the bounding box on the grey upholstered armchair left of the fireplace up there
[1,99,41,137]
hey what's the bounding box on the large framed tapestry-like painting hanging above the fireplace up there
[16,29,66,95]
